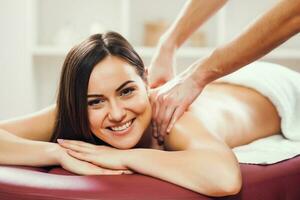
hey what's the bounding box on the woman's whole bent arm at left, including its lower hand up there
[0,106,131,175]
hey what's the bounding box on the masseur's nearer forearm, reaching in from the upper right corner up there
[190,0,300,86]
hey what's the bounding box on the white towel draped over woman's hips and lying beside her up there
[218,62,300,164]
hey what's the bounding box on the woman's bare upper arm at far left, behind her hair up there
[0,105,56,141]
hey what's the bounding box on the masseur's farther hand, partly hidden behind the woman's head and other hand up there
[148,42,175,88]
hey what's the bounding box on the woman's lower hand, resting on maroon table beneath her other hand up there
[57,141,132,175]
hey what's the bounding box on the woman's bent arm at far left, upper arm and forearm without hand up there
[0,106,59,166]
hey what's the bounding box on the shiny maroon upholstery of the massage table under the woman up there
[0,157,300,200]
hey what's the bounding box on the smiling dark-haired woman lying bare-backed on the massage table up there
[0,32,292,196]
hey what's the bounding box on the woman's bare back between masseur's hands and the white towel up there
[165,83,280,150]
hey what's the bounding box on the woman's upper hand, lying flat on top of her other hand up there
[58,140,133,174]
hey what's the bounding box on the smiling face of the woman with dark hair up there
[87,56,151,149]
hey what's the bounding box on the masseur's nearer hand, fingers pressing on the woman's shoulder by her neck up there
[150,75,202,144]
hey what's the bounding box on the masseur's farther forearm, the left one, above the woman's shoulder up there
[162,0,227,49]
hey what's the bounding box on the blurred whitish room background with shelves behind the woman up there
[0,0,300,120]
